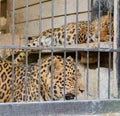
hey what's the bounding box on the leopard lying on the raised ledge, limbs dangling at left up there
[1,12,114,64]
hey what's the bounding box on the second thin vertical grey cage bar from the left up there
[25,0,28,101]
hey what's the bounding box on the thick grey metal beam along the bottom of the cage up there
[0,100,120,116]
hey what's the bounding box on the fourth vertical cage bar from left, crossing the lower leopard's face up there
[50,0,54,101]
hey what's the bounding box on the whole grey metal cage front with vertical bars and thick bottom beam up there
[0,0,120,116]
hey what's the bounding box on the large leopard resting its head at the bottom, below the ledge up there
[0,55,85,103]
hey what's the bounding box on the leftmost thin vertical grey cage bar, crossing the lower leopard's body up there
[12,0,15,102]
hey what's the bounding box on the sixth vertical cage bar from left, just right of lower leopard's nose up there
[75,0,79,100]
